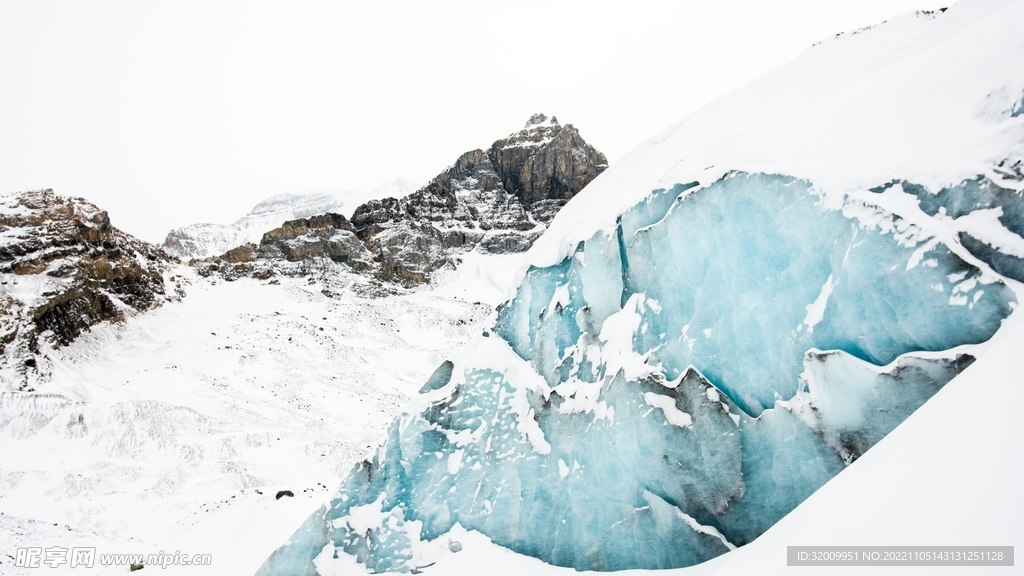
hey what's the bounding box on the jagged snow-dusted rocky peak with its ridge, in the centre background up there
[194,114,607,287]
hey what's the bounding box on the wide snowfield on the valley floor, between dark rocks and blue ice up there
[0,255,521,574]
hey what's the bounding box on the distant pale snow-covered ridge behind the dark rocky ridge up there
[164,178,420,258]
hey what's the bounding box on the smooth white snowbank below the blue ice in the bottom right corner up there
[700,315,1024,576]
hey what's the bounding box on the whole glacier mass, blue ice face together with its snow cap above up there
[260,0,1024,575]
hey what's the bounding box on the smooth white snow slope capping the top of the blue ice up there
[530,0,1024,265]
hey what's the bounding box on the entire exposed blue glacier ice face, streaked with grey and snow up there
[260,172,1016,575]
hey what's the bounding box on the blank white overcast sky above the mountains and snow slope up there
[0,0,949,241]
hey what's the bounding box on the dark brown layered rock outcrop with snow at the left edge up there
[0,190,183,387]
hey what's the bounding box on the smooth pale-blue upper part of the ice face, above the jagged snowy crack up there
[497,170,1014,416]
